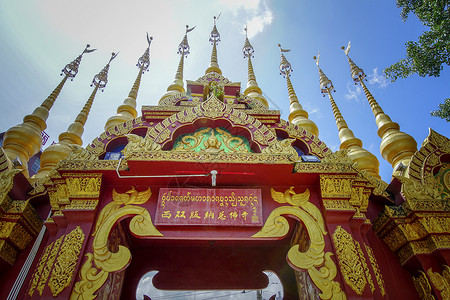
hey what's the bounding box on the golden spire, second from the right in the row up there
[314,54,381,179]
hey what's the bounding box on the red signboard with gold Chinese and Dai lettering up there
[155,188,262,226]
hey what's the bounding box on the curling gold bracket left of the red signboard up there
[70,187,163,299]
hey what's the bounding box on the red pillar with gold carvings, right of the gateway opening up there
[320,174,386,299]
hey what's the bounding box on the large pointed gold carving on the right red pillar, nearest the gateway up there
[333,226,367,295]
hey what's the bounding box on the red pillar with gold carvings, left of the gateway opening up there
[26,173,102,299]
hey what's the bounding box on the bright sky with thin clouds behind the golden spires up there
[0,0,450,182]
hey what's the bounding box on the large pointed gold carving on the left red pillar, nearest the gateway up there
[48,226,85,297]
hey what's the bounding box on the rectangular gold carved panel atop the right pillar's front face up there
[320,175,353,198]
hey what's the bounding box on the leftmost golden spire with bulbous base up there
[3,45,95,177]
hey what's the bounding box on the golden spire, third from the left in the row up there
[105,33,153,131]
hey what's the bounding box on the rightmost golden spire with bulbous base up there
[342,42,417,172]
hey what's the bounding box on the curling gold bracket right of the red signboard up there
[252,187,347,299]
